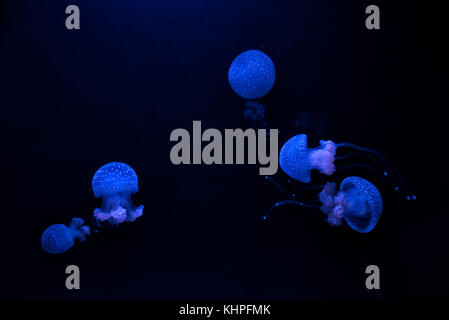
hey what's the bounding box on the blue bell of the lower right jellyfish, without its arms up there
[340,177,382,233]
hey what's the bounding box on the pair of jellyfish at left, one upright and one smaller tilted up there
[41,162,143,254]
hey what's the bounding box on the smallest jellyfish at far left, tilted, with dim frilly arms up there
[41,218,90,254]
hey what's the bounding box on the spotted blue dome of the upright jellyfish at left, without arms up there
[92,162,139,198]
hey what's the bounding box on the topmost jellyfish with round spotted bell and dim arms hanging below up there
[228,50,276,126]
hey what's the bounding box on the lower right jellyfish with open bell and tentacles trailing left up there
[264,176,383,233]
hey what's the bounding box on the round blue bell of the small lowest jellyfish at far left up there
[41,224,74,254]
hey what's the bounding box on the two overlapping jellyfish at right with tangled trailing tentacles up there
[264,130,416,233]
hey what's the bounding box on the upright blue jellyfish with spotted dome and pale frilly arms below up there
[92,162,143,225]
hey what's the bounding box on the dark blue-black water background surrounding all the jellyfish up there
[0,0,449,299]
